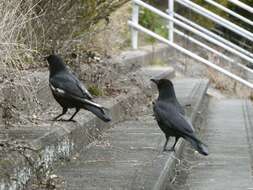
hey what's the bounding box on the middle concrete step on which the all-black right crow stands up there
[57,78,208,190]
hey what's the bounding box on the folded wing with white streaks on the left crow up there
[49,72,92,100]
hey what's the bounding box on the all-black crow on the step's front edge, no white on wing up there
[151,79,208,155]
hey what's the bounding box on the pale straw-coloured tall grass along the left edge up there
[0,0,44,127]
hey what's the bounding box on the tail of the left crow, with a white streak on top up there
[84,101,111,122]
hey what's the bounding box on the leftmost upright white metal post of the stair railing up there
[132,2,139,49]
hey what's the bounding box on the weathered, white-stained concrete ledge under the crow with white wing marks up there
[0,88,153,190]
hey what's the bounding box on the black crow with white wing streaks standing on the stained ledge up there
[46,55,111,122]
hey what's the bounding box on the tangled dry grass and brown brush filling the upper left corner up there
[0,0,128,127]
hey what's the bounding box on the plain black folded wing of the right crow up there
[154,101,194,134]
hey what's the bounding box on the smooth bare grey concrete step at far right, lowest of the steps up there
[185,99,253,190]
